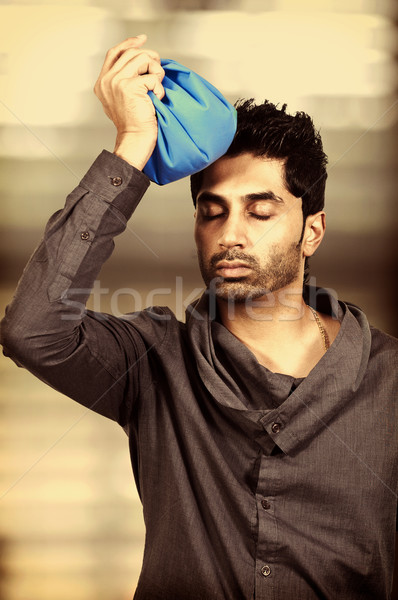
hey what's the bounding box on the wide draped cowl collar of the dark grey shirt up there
[187,288,370,454]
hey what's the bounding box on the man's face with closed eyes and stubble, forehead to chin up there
[195,154,304,302]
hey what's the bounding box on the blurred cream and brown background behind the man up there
[0,0,398,600]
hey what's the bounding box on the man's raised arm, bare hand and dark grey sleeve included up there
[1,37,164,424]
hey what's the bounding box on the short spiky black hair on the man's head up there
[191,99,327,224]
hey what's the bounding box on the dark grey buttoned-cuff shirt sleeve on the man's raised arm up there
[1,150,154,425]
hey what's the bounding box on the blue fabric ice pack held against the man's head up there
[144,59,236,185]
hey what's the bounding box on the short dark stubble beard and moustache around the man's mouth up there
[198,242,301,303]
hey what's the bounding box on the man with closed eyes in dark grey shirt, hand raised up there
[2,37,397,600]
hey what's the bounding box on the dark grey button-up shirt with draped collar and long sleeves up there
[2,151,397,600]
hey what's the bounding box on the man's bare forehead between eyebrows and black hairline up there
[198,154,297,201]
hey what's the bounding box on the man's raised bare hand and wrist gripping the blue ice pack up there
[94,35,165,169]
